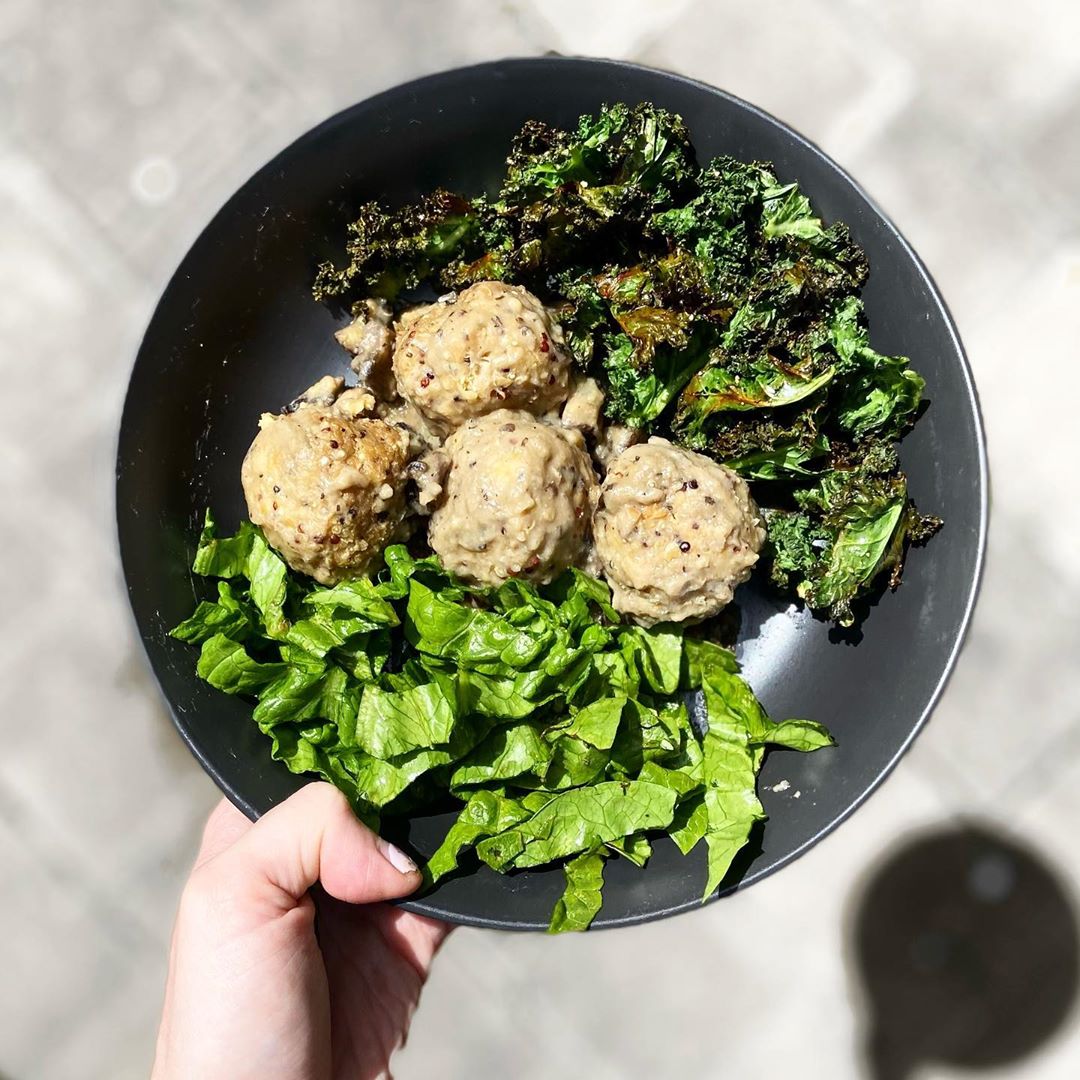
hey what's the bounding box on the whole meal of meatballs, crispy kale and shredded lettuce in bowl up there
[174,105,936,930]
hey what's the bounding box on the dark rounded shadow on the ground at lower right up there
[849,823,1078,1080]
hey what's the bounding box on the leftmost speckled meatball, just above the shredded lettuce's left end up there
[241,405,407,584]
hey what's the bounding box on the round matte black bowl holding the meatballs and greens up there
[117,57,987,929]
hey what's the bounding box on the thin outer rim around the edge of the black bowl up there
[113,54,989,930]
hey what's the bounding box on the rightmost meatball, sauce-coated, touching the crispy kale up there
[593,438,765,625]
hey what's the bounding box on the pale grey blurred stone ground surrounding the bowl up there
[0,0,1080,1080]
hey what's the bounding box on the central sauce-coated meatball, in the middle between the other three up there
[428,409,596,584]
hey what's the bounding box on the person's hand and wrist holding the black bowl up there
[153,783,448,1080]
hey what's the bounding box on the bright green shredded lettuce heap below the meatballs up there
[173,513,832,932]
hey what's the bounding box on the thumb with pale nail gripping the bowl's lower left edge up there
[204,783,420,909]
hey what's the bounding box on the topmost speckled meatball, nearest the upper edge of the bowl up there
[393,281,569,430]
